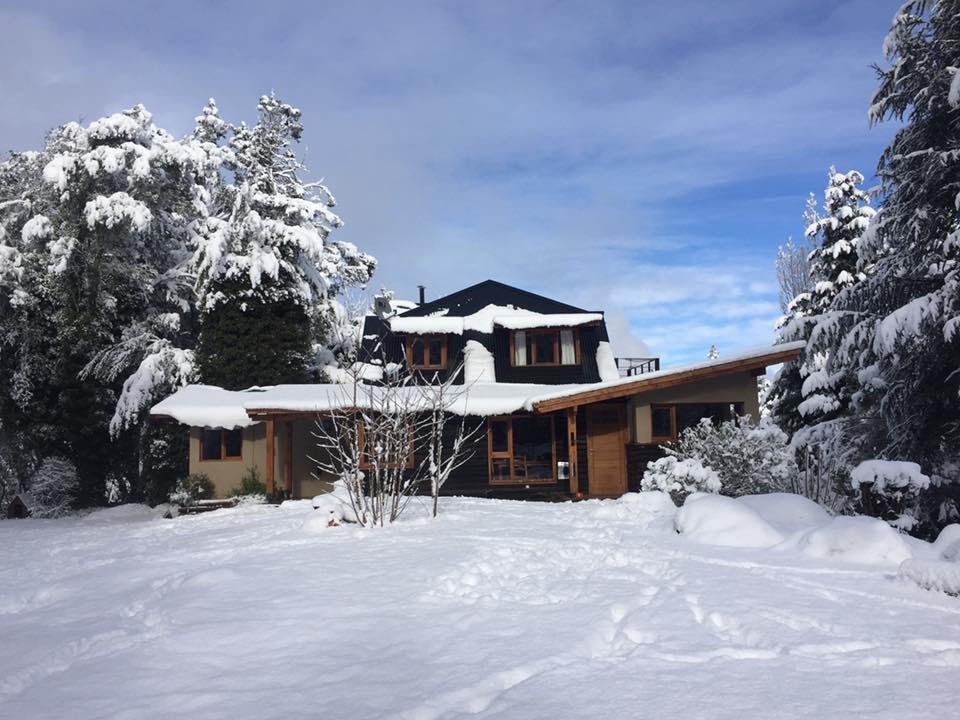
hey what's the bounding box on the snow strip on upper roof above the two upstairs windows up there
[390,305,603,335]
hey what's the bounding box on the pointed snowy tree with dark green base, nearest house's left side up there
[194,95,376,388]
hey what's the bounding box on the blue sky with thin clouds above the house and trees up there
[0,0,900,364]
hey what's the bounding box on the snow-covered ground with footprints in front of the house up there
[0,493,960,720]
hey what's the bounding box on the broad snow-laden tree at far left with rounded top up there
[4,106,216,504]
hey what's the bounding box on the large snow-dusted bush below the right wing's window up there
[666,415,797,497]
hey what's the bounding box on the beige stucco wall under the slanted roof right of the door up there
[628,372,760,443]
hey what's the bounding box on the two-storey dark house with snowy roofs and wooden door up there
[151,280,802,498]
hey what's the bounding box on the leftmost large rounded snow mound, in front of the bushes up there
[674,493,783,548]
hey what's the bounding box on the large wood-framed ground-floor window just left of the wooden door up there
[487,415,568,485]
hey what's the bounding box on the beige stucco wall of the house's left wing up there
[190,420,332,498]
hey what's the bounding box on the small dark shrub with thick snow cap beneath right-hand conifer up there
[850,460,930,532]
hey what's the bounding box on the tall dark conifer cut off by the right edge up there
[834,0,960,531]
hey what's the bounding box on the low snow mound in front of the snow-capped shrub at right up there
[797,516,913,565]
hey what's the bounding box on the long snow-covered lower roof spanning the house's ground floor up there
[150,341,803,428]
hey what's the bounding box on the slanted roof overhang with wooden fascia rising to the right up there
[531,340,806,413]
